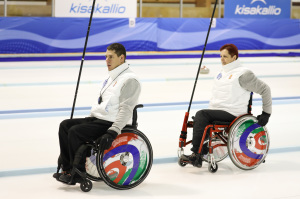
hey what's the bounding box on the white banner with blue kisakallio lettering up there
[55,0,137,18]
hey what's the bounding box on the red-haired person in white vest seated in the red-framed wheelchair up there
[184,44,272,167]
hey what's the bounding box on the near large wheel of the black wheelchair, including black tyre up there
[97,128,153,190]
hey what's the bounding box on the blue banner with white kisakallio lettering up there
[224,0,291,18]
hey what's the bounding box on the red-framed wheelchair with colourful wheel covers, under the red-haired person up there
[178,98,270,173]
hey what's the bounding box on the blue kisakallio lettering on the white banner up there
[69,3,126,14]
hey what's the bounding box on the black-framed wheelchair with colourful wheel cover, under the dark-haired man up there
[57,104,153,192]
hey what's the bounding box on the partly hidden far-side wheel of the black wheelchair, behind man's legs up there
[85,149,102,181]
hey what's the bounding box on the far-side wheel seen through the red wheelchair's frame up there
[202,139,228,162]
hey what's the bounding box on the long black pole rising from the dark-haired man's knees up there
[71,0,96,119]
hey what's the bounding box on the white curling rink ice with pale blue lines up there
[0,53,300,199]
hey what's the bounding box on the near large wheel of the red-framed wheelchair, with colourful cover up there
[227,115,270,170]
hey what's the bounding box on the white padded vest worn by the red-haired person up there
[209,60,250,116]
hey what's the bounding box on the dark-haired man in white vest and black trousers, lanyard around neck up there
[53,43,141,184]
